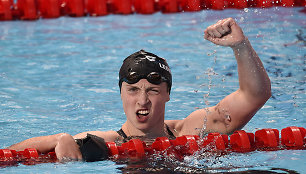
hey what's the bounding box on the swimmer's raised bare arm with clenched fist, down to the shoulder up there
[178,18,271,134]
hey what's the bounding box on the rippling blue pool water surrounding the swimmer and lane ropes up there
[0,7,306,173]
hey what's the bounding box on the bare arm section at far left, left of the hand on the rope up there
[8,133,65,153]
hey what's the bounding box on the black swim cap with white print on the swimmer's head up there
[119,50,172,93]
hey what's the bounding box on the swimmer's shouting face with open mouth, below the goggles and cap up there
[121,79,170,132]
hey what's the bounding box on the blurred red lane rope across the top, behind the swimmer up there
[0,0,306,21]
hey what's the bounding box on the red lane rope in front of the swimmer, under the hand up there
[0,126,306,167]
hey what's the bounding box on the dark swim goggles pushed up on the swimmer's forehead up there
[121,72,169,85]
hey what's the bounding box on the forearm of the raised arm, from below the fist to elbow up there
[232,39,271,102]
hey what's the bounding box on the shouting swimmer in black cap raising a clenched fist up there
[8,18,271,161]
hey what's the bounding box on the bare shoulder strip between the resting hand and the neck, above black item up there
[73,131,119,142]
